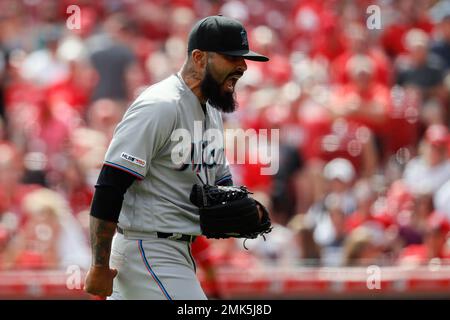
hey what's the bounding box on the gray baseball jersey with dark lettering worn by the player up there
[105,74,231,235]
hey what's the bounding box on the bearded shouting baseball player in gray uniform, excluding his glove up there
[85,16,269,300]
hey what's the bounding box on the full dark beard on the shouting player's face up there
[200,66,237,113]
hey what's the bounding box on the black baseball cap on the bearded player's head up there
[188,16,269,61]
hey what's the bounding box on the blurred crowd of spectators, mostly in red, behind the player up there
[0,0,450,277]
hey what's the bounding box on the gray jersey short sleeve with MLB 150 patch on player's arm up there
[104,102,177,180]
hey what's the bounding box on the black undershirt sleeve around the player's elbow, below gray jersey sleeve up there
[91,165,136,222]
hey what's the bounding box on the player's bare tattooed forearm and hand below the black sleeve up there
[84,216,117,297]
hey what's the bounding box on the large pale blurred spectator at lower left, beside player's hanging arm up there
[3,189,89,269]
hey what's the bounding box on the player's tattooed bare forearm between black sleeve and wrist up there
[90,216,117,266]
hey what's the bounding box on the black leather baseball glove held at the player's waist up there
[190,184,272,239]
